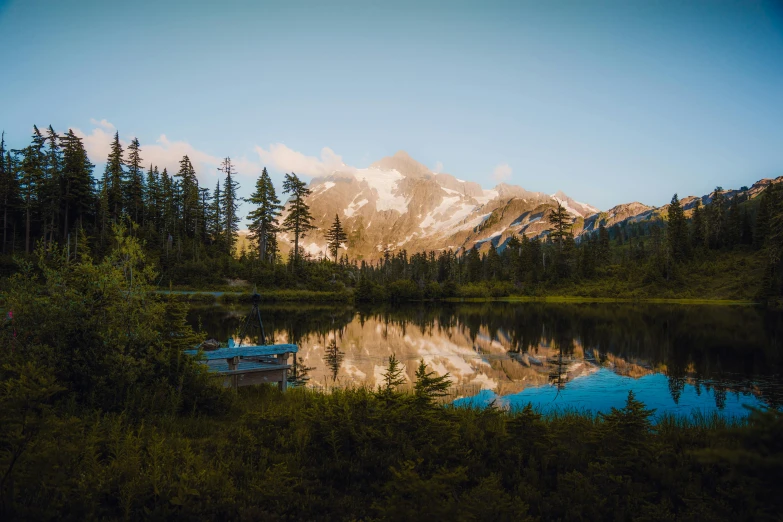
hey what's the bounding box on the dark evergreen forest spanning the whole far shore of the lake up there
[0,127,783,301]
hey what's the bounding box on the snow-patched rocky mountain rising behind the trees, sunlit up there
[281,151,783,260]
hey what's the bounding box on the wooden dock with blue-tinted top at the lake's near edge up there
[185,344,299,391]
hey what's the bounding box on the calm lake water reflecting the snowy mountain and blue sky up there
[189,303,783,415]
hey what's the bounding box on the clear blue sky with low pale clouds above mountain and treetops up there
[0,0,783,209]
